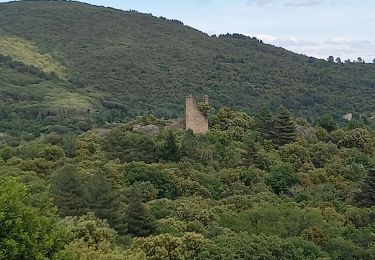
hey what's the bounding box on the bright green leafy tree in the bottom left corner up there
[0,178,69,260]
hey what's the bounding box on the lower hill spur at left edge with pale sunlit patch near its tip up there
[0,55,98,138]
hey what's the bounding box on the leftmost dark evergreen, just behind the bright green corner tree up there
[51,165,87,217]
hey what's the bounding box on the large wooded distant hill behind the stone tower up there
[0,1,375,136]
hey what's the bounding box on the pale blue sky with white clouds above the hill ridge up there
[0,0,375,62]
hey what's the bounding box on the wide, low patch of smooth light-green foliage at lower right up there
[220,202,345,240]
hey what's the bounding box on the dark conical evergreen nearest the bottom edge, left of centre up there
[125,190,157,237]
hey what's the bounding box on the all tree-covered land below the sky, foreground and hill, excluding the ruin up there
[0,1,375,260]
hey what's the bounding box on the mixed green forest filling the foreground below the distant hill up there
[0,108,375,260]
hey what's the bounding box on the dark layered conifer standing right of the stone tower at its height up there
[273,107,296,146]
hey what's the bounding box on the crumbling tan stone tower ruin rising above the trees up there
[185,95,208,134]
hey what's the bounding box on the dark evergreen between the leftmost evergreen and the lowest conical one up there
[87,172,124,233]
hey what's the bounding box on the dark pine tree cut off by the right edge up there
[355,169,375,207]
